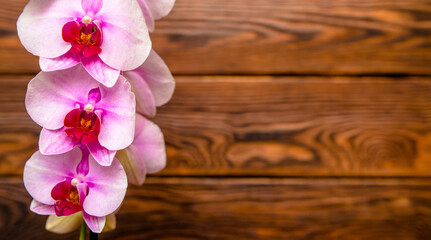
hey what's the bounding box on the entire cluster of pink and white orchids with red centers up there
[17,0,175,236]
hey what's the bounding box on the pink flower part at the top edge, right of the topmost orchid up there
[138,0,175,32]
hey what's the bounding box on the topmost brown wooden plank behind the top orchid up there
[0,0,431,75]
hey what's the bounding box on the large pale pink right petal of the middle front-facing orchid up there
[95,76,135,150]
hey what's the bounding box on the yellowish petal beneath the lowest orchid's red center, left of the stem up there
[45,212,82,234]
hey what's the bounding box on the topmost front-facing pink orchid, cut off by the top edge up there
[17,0,151,87]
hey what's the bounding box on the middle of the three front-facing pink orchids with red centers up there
[25,66,135,166]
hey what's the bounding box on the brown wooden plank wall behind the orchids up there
[0,0,431,240]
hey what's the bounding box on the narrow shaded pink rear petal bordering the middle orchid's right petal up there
[124,71,156,117]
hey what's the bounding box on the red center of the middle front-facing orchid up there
[64,108,100,144]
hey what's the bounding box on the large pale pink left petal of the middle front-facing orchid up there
[25,65,99,130]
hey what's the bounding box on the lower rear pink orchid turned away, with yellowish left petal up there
[117,114,166,185]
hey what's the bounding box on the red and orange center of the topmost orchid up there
[62,16,102,57]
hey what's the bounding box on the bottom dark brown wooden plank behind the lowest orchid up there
[0,178,431,240]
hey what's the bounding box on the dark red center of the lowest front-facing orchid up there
[51,180,82,216]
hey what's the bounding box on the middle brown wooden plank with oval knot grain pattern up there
[0,76,431,177]
